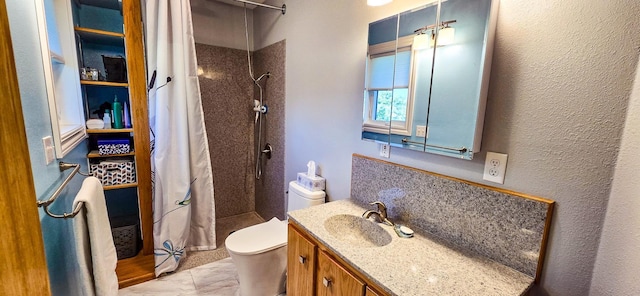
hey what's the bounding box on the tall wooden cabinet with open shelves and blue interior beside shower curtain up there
[68,0,155,287]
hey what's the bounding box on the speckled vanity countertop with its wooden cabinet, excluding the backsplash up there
[287,200,534,295]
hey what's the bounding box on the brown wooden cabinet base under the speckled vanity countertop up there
[287,222,386,296]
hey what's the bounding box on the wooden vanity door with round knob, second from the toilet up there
[316,251,365,296]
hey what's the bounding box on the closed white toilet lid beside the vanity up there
[225,217,287,255]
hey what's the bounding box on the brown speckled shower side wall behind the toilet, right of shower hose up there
[253,40,286,220]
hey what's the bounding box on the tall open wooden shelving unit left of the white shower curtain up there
[74,0,155,288]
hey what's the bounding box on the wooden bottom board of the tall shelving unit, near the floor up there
[116,252,156,289]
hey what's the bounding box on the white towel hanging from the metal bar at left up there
[73,177,118,296]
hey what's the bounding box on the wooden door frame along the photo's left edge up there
[0,0,51,296]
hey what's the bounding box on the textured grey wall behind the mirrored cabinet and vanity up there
[254,0,640,295]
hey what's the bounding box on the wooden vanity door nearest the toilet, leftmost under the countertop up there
[287,225,317,295]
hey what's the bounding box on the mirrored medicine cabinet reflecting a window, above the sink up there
[362,0,497,159]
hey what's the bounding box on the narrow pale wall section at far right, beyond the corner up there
[590,55,640,296]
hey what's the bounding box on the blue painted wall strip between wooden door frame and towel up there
[6,0,87,295]
